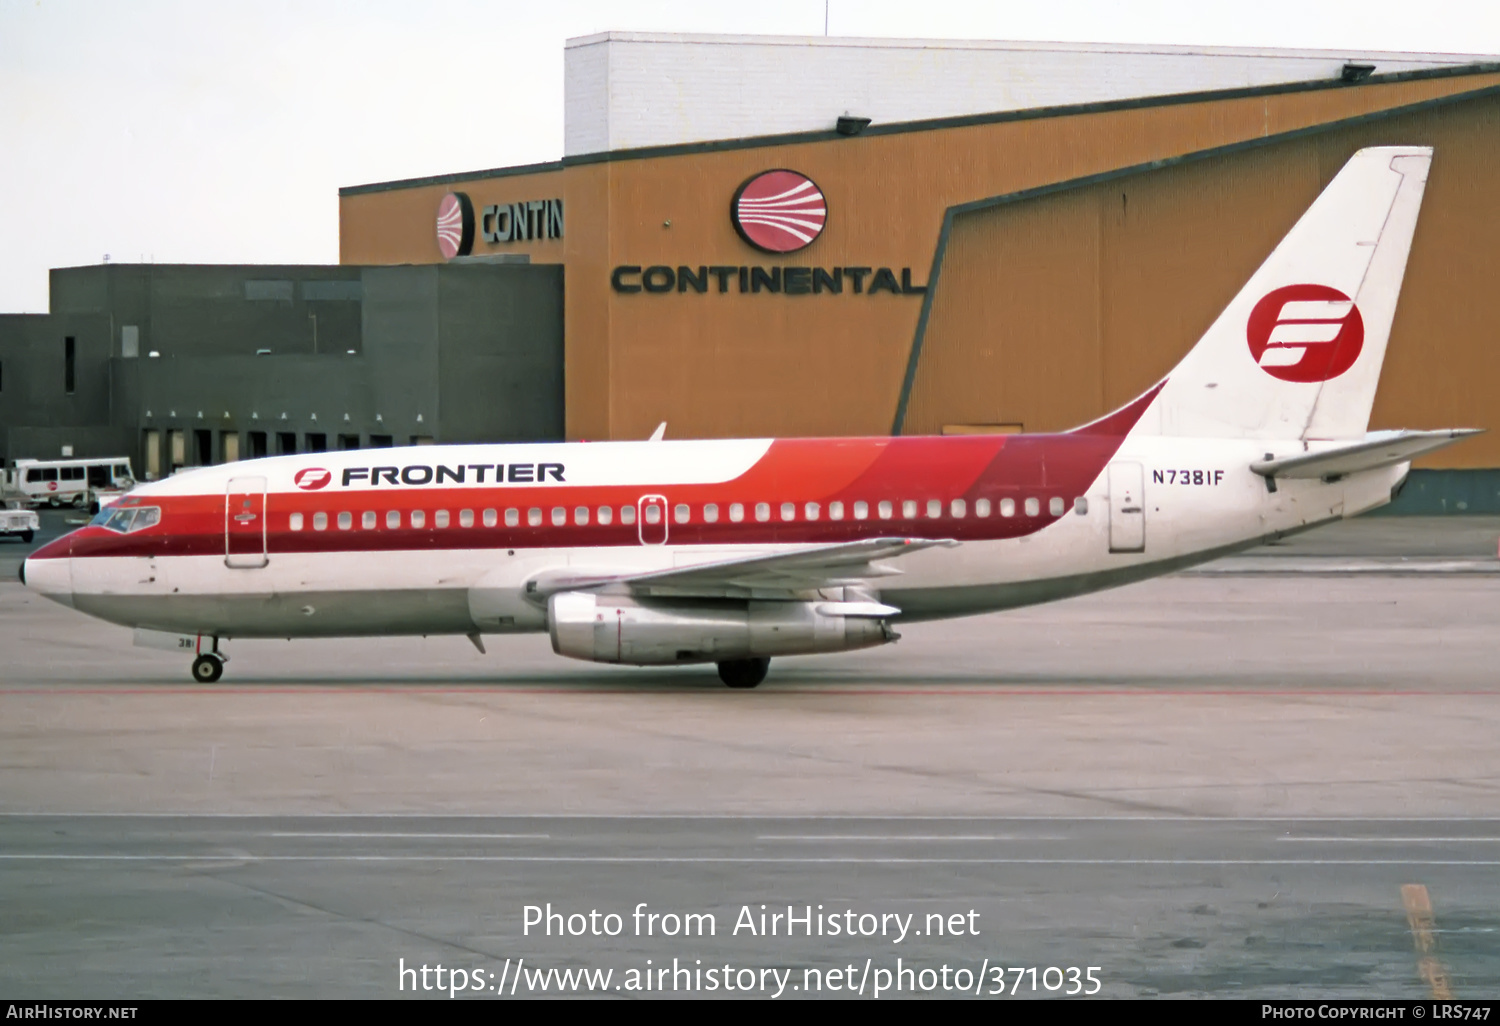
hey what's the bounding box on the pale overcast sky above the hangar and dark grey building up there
[0,0,1500,312]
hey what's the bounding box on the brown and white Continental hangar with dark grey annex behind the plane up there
[0,33,1500,510]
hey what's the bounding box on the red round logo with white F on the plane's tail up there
[1245,285,1365,383]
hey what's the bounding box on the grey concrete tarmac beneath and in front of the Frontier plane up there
[0,515,1500,1001]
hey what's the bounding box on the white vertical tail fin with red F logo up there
[1136,146,1433,440]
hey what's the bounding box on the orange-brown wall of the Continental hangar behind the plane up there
[341,65,1500,465]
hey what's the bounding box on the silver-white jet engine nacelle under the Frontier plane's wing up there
[548,591,897,666]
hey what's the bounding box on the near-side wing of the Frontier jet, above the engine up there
[528,539,959,600]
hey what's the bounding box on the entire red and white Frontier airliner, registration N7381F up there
[23,147,1472,687]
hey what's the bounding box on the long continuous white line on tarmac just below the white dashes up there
[0,854,1500,869]
